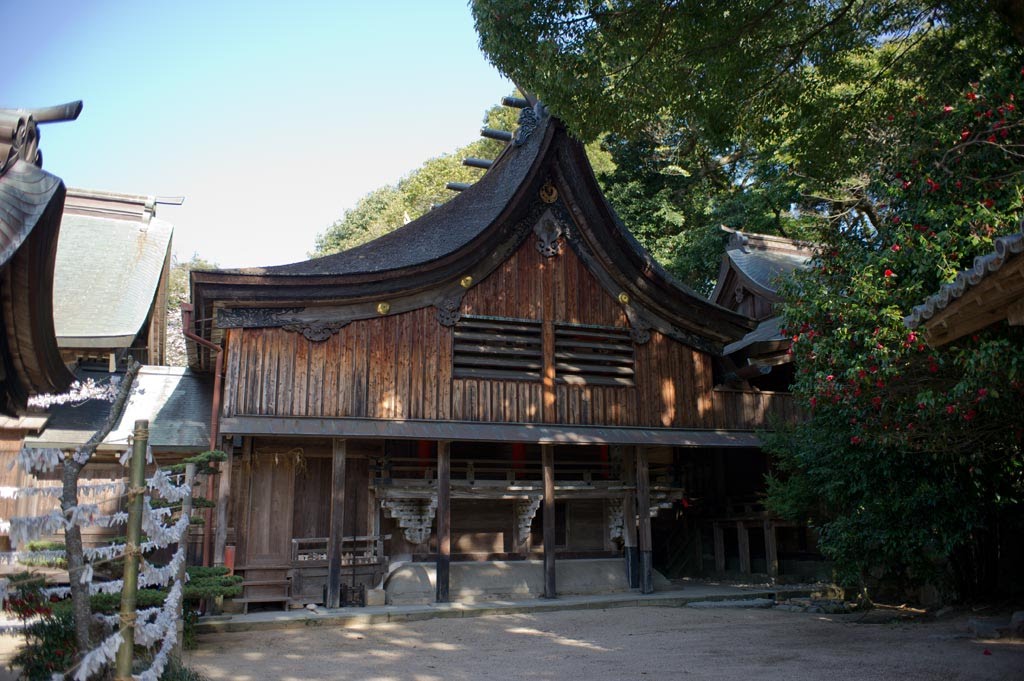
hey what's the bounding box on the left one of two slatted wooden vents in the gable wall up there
[453,314,544,381]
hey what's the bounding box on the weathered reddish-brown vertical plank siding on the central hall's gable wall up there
[224,239,798,429]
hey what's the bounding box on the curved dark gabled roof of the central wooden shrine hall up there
[191,104,754,366]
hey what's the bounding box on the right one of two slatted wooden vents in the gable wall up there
[555,324,635,386]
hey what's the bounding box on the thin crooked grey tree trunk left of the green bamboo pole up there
[60,361,141,655]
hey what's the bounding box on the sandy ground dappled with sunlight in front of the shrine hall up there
[187,607,1024,681]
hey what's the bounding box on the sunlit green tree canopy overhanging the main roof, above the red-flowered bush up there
[473,0,1015,292]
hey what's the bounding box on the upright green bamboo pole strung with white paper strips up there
[114,420,150,681]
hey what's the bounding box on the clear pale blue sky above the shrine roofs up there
[0,0,512,267]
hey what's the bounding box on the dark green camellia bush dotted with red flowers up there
[767,62,1024,597]
